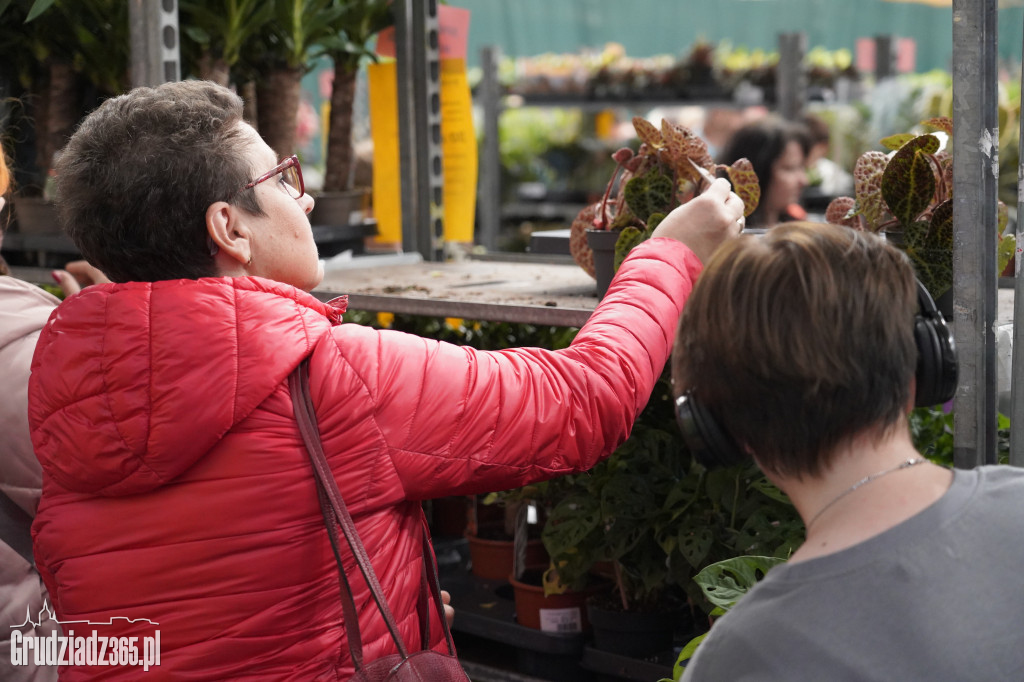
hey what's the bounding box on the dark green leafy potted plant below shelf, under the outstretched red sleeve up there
[543,376,804,657]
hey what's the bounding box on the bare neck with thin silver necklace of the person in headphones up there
[775,425,952,560]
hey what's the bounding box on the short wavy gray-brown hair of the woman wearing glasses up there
[56,81,262,282]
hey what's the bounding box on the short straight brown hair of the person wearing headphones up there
[672,222,918,477]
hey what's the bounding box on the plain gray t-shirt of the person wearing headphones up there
[682,466,1024,682]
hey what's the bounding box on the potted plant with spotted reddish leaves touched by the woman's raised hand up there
[569,117,761,297]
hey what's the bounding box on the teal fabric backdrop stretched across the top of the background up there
[449,0,1024,71]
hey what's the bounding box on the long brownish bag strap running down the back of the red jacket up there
[288,360,409,665]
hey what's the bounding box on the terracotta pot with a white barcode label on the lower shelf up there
[509,566,611,634]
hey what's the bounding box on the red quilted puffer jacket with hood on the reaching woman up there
[29,240,700,681]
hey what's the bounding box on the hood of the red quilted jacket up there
[29,278,344,496]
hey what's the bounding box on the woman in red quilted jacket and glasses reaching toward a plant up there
[29,81,742,681]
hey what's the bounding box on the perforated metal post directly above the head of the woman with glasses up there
[128,0,181,88]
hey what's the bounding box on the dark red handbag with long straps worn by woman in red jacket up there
[288,360,469,682]
